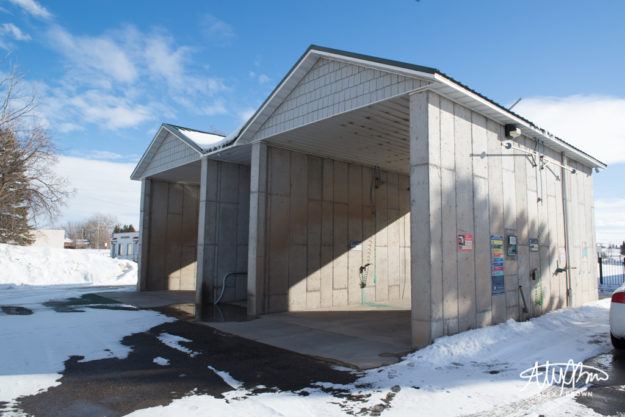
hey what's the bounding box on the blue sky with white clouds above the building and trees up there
[0,0,625,241]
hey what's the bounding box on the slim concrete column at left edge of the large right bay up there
[247,143,267,316]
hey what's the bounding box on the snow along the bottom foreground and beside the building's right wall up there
[130,300,611,417]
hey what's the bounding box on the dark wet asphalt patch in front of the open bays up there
[13,312,357,417]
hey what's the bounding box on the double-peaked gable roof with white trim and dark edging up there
[131,45,606,179]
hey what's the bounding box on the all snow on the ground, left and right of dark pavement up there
[0,245,611,416]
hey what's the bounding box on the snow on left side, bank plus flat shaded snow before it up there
[0,244,173,408]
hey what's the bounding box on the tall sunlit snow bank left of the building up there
[0,240,137,285]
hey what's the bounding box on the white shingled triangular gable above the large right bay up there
[250,58,428,142]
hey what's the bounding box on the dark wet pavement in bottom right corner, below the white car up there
[575,350,625,416]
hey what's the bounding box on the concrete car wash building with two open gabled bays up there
[132,46,606,346]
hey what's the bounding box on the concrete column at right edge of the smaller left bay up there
[195,158,213,308]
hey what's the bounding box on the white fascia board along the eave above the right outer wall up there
[433,73,607,169]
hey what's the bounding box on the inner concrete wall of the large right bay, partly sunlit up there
[258,147,410,311]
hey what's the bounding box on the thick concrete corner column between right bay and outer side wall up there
[410,91,442,347]
